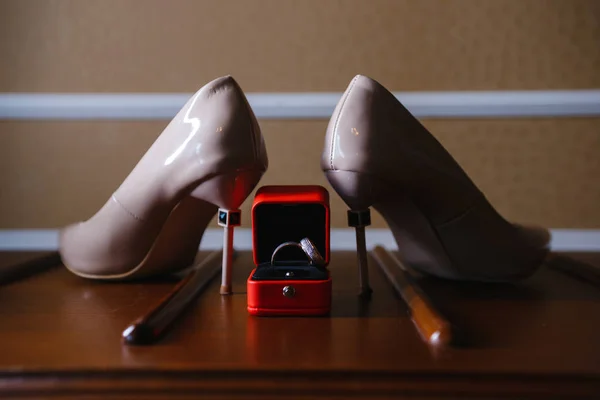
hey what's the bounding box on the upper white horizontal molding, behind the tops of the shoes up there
[0,90,600,120]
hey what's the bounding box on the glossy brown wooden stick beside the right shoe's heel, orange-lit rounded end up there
[371,246,452,345]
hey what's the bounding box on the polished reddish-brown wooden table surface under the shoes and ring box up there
[0,252,600,399]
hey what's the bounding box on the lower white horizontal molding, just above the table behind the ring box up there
[0,228,600,252]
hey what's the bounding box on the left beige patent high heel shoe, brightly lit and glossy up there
[60,77,268,293]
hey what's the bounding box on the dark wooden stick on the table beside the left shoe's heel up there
[122,250,222,345]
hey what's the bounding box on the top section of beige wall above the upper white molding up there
[0,0,600,92]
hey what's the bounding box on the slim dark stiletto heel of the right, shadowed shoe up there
[325,171,392,298]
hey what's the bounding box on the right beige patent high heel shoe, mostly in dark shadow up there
[321,75,549,294]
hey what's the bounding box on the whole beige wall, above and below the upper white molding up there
[0,0,600,229]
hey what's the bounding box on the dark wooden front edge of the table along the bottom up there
[0,369,600,398]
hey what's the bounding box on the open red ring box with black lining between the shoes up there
[247,185,331,316]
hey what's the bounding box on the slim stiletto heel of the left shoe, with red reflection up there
[190,170,264,294]
